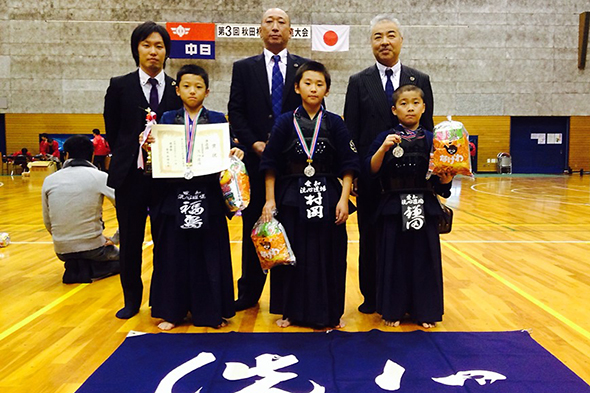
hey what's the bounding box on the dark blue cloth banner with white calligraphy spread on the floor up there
[78,330,590,393]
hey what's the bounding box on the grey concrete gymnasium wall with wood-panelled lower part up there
[0,0,590,171]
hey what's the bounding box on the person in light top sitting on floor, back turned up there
[42,135,119,284]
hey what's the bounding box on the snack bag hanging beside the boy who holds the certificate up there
[219,156,250,213]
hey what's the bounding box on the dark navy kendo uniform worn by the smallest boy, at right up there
[364,126,451,323]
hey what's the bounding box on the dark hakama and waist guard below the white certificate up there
[150,174,235,327]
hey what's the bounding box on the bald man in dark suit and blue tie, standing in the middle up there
[228,8,308,311]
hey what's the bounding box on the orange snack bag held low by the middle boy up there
[251,217,295,271]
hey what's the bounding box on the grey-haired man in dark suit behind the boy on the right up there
[344,15,434,314]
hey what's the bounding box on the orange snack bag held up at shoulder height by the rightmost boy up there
[426,116,473,179]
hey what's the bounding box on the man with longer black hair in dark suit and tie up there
[104,22,182,319]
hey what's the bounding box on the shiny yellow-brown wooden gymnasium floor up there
[0,175,590,393]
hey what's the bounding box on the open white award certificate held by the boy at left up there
[151,123,231,180]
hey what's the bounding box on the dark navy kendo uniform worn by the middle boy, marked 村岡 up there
[260,107,359,328]
